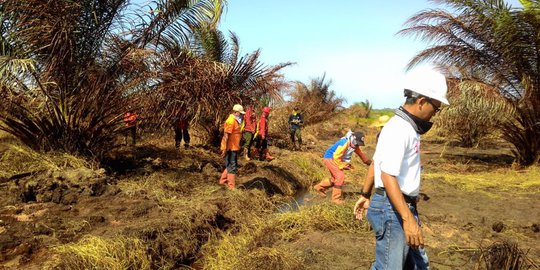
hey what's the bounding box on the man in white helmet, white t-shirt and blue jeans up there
[354,67,449,269]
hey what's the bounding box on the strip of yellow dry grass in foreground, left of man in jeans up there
[203,203,369,269]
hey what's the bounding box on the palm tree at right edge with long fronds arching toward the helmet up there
[400,0,540,166]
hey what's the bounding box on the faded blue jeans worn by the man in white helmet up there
[367,194,429,270]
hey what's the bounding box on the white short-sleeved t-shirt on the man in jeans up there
[373,116,421,196]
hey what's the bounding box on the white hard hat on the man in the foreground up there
[404,68,450,105]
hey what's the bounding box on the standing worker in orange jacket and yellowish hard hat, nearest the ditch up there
[219,104,246,189]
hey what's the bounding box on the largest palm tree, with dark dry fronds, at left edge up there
[0,0,222,157]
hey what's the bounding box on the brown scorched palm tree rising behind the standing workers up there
[149,21,291,145]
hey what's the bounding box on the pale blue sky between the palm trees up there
[220,0,521,109]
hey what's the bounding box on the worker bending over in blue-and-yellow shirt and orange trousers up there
[314,131,371,204]
